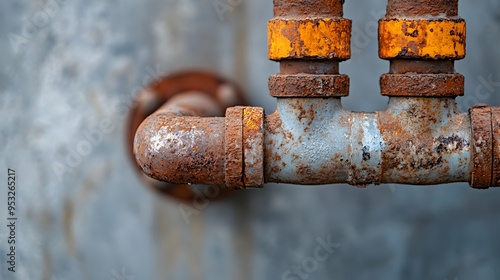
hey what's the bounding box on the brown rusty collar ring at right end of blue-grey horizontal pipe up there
[469,105,493,189]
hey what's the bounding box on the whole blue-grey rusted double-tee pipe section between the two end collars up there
[265,98,471,185]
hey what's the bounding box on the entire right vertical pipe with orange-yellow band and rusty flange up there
[379,0,466,97]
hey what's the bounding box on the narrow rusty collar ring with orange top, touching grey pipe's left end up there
[243,107,264,188]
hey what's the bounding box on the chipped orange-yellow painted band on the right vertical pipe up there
[379,19,466,59]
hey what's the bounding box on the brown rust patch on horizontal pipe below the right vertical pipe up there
[378,98,470,184]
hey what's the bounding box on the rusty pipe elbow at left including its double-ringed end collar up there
[134,105,264,189]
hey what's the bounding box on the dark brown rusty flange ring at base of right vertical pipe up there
[380,74,465,97]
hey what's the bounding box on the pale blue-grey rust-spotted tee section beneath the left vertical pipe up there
[264,98,351,185]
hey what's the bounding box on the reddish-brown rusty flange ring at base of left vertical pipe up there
[269,74,349,97]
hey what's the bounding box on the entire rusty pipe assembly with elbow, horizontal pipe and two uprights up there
[133,0,500,190]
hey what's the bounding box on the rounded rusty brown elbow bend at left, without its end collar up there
[134,113,225,185]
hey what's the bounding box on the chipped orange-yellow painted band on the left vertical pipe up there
[267,18,351,60]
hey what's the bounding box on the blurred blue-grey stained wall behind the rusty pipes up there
[0,0,500,280]
